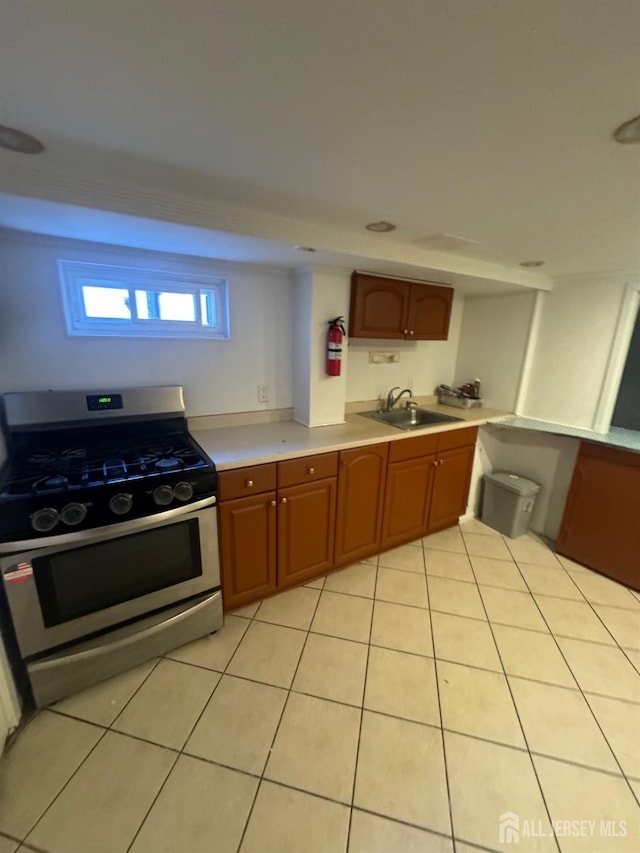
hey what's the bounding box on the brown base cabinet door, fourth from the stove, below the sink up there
[381,456,436,548]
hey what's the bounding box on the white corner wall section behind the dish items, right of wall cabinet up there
[453,292,535,412]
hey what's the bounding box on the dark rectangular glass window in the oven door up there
[33,519,202,628]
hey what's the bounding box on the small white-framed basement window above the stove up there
[58,261,229,339]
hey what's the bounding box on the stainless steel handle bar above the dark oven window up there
[0,495,216,556]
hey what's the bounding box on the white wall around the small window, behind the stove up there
[0,231,293,416]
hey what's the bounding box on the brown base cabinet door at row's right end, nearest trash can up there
[429,446,475,531]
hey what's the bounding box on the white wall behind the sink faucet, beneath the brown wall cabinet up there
[346,293,462,402]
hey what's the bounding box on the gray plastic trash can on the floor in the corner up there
[482,471,542,539]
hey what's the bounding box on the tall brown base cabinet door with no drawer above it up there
[335,444,389,565]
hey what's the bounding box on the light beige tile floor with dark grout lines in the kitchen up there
[0,521,640,853]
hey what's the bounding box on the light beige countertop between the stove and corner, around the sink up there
[190,405,507,471]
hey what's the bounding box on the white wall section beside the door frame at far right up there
[523,276,627,429]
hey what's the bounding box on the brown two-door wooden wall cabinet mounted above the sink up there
[349,272,453,341]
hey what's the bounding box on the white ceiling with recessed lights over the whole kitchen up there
[0,0,640,283]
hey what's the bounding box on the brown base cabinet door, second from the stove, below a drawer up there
[278,477,336,589]
